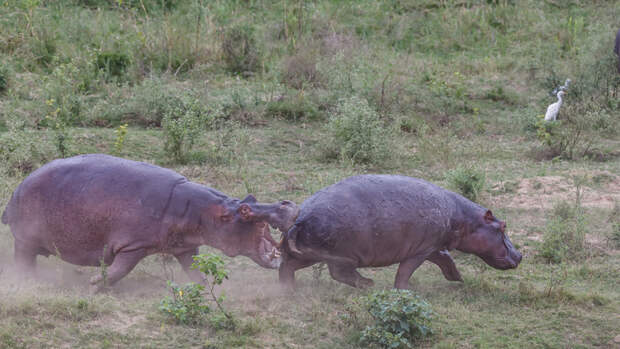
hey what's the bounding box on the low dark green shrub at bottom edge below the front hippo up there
[361,289,433,348]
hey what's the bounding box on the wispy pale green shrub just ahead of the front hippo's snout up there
[540,201,587,263]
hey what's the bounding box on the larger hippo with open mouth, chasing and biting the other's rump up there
[2,154,299,292]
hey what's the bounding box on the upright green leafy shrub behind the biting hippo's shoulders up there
[161,97,209,163]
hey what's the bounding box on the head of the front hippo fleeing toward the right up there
[456,210,521,270]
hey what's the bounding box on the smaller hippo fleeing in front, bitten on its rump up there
[279,175,521,289]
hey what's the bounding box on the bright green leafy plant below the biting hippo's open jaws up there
[159,253,236,329]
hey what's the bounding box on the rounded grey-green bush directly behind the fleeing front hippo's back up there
[324,97,390,164]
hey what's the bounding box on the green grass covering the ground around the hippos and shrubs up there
[0,0,620,348]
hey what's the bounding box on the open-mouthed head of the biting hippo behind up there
[205,195,299,269]
